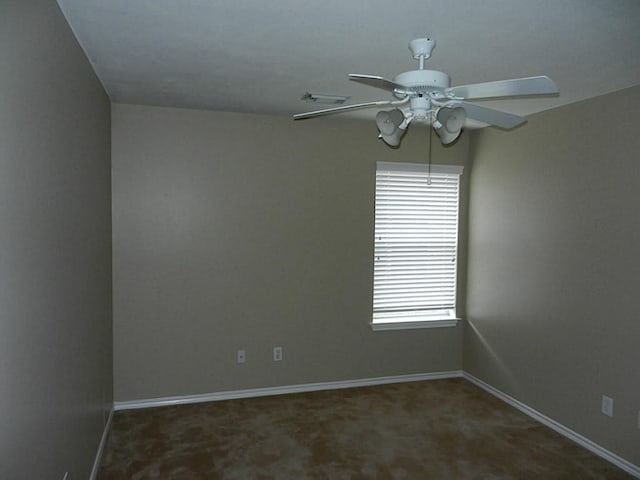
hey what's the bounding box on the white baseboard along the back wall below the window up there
[114,370,463,410]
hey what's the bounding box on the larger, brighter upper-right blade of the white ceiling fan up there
[444,75,559,99]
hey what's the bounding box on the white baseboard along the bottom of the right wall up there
[463,372,640,478]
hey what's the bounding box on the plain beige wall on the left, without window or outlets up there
[0,0,112,480]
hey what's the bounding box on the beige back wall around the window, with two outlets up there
[113,105,467,401]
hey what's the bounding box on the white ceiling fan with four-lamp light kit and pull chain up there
[293,38,559,147]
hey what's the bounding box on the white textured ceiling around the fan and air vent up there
[58,0,640,122]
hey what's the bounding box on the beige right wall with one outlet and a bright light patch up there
[464,87,640,465]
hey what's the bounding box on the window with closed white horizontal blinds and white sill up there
[372,162,463,330]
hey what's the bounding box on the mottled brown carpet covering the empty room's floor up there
[98,379,632,480]
